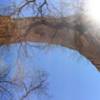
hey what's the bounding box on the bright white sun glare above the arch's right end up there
[86,0,100,24]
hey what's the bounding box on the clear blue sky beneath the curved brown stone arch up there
[0,0,100,100]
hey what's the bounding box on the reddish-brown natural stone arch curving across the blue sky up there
[0,16,100,70]
